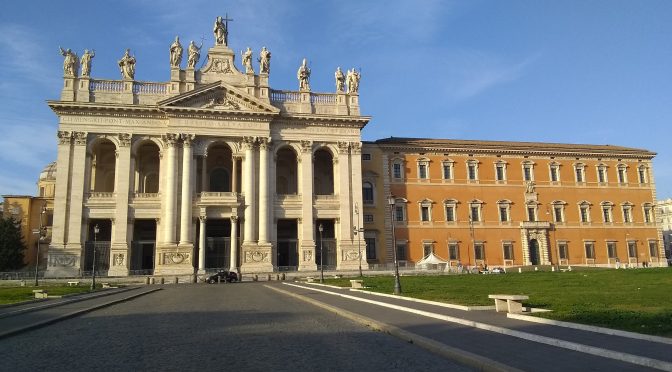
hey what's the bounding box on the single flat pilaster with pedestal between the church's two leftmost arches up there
[109,133,132,276]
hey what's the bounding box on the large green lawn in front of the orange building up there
[328,268,672,337]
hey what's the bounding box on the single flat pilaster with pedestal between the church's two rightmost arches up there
[299,141,317,271]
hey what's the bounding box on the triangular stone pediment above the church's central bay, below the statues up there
[158,81,280,114]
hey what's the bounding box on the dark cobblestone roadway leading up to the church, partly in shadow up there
[0,283,468,371]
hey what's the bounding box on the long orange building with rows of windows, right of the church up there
[362,138,665,267]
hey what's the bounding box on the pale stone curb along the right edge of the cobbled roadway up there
[264,285,520,372]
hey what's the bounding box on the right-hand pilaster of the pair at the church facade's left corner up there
[66,132,87,252]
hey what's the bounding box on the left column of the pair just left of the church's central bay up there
[161,133,179,245]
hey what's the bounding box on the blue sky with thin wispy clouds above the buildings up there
[0,0,672,199]
